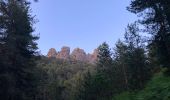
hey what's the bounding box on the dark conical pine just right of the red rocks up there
[96,42,117,100]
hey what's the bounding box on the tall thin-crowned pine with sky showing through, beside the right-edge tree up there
[125,23,150,89]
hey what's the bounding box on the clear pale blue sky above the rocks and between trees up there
[31,0,137,55]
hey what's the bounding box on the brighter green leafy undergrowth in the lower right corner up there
[113,72,170,100]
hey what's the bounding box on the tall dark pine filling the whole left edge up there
[0,0,38,100]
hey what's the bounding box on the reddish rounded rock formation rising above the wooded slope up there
[47,46,98,63]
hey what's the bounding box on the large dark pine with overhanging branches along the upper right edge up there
[128,0,170,69]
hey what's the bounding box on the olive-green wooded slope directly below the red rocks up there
[36,57,95,100]
